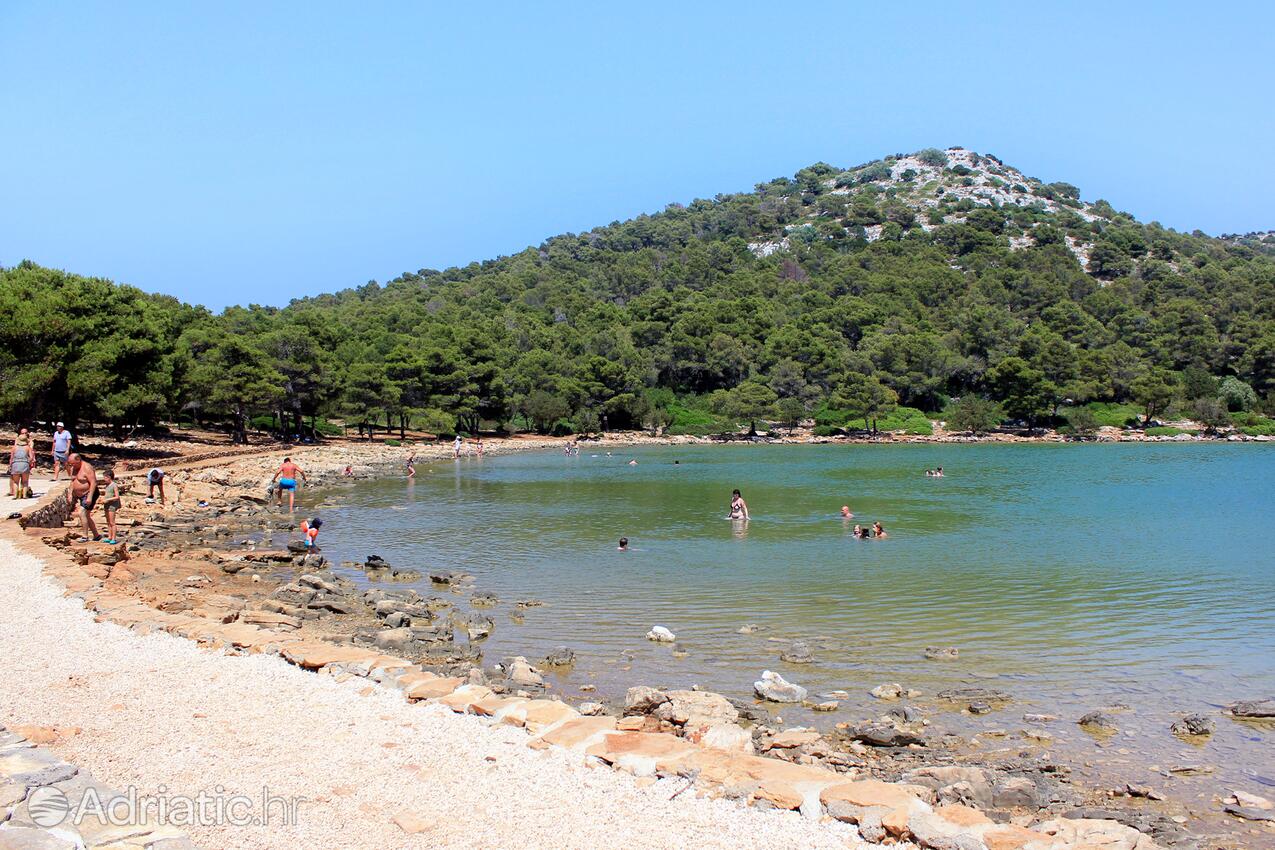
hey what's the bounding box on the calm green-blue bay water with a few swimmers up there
[323,445,1275,793]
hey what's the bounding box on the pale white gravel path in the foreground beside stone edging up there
[0,539,861,850]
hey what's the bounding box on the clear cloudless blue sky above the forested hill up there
[0,0,1275,308]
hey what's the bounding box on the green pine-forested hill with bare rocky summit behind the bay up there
[0,148,1275,431]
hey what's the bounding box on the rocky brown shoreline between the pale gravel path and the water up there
[4,440,1275,850]
